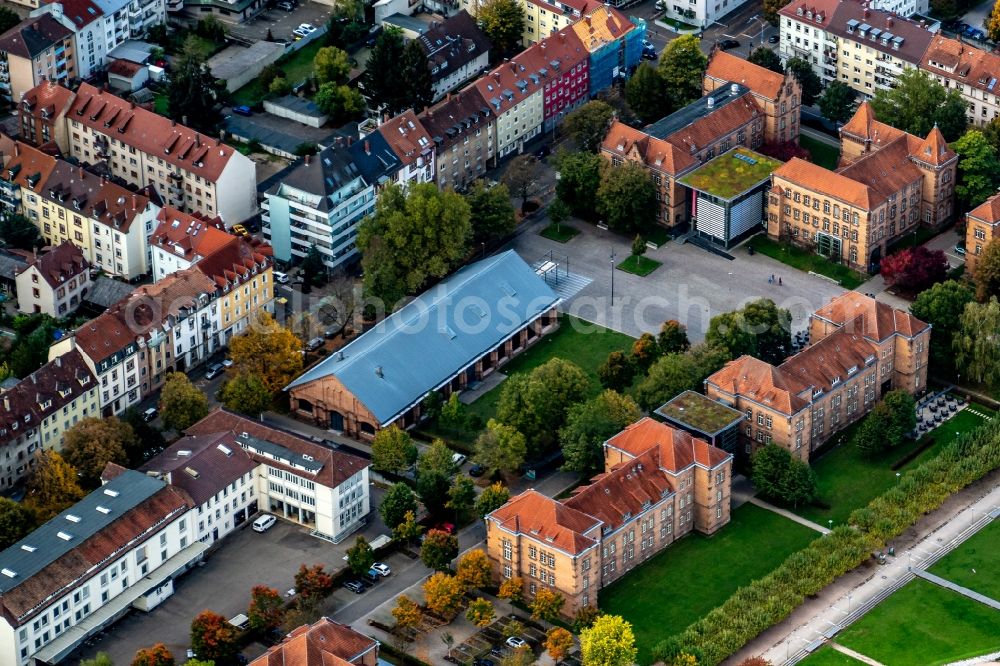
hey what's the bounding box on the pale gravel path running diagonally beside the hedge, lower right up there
[731,471,1000,664]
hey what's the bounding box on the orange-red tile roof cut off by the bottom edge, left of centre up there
[250,617,378,666]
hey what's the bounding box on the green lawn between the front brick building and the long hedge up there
[600,504,819,664]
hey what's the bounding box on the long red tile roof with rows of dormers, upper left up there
[67,83,236,183]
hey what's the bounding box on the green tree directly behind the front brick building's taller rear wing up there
[559,390,642,476]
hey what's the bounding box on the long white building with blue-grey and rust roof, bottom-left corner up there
[0,468,208,666]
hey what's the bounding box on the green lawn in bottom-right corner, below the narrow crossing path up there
[837,579,1000,666]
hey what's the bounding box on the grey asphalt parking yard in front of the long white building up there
[66,488,394,664]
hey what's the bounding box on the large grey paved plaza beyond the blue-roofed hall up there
[511,219,845,342]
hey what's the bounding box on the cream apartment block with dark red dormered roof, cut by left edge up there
[0,351,100,491]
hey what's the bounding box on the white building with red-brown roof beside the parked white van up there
[185,407,371,543]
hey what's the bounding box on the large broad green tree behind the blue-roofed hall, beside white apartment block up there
[357,183,472,308]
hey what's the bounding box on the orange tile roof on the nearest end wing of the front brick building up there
[487,490,600,554]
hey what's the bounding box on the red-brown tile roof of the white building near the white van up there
[184,407,370,488]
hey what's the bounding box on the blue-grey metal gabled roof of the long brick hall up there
[286,250,560,425]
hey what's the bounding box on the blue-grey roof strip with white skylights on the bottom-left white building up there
[0,470,167,594]
